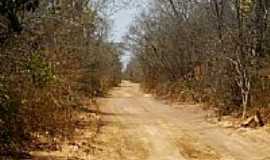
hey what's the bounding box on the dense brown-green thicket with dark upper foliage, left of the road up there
[0,0,121,155]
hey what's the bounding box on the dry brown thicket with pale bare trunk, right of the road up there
[127,0,270,118]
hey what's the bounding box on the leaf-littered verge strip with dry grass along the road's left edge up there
[31,100,100,160]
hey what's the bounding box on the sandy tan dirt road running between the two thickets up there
[97,81,270,160]
